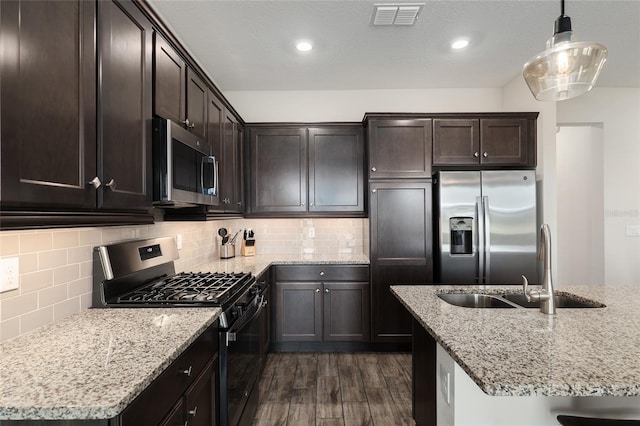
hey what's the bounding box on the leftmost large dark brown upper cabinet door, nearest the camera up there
[0,1,97,210]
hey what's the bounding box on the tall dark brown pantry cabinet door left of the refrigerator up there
[369,179,433,343]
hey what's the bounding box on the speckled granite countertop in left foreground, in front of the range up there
[0,308,220,423]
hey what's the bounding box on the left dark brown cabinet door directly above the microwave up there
[153,32,187,123]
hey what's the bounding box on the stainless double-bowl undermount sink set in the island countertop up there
[438,293,605,308]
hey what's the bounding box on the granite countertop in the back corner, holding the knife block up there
[190,254,369,276]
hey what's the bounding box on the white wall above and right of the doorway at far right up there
[557,88,640,284]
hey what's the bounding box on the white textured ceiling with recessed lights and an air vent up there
[148,0,640,92]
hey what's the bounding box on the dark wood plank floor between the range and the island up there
[253,353,415,426]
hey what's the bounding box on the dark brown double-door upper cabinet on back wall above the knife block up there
[248,125,365,216]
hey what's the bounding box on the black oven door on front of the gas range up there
[220,295,266,425]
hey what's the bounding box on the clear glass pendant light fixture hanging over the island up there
[522,0,607,101]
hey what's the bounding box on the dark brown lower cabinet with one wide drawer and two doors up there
[274,265,370,342]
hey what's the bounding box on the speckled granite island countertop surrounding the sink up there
[391,285,640,396]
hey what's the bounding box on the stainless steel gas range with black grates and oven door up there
[93,237,267,426]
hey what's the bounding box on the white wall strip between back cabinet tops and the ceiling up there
[224,89,502,123]
